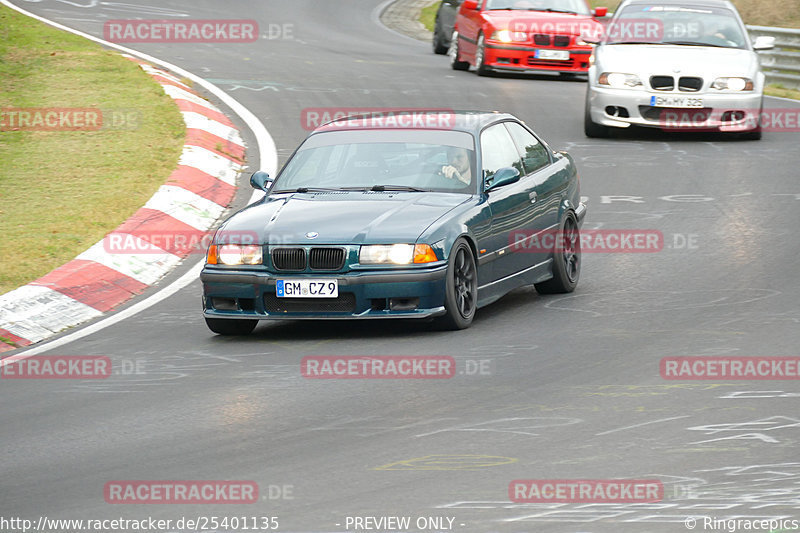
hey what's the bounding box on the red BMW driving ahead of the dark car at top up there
[449,0,608,76]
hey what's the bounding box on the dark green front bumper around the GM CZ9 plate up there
[200,264,447,320]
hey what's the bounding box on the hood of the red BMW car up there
[482,10,603,35]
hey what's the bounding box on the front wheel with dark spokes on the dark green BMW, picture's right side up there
[438,238,478,330]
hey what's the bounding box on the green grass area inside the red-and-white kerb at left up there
[0,7,185,294]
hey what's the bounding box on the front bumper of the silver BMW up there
[587,86,762,132]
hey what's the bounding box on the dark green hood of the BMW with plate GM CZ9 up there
[220,191,472,244]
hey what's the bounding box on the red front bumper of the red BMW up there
[484,42,592,73]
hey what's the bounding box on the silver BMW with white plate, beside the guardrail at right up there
[584,0,775,139]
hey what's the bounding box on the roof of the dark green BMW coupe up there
[312,108,520,135]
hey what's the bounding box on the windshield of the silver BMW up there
[606,4,747,48]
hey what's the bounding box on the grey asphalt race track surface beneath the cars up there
[0,0,800,533]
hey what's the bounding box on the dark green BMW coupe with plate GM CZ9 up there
[201,111,586,335]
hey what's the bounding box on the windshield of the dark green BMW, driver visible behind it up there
[273,131,476,193]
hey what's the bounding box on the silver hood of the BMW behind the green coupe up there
[595,44,758,77]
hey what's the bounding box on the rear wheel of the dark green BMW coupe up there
[534,211,581,294]
